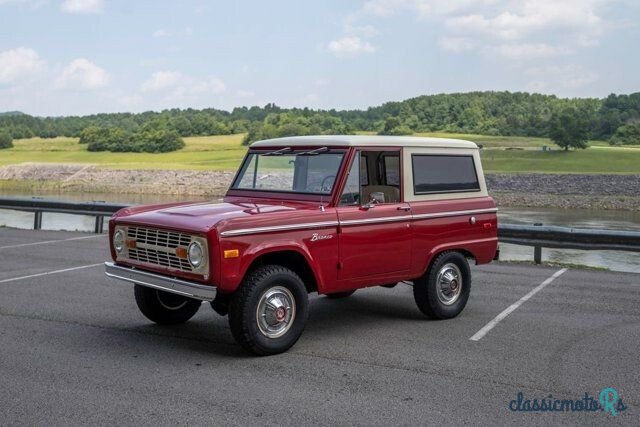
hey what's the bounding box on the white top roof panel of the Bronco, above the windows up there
[251,135,478,148]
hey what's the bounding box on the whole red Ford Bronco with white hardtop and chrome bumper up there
[105,136,498,355]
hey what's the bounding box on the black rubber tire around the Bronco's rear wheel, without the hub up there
[413,251,471,320]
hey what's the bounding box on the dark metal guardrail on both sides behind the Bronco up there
[0,197,640,264]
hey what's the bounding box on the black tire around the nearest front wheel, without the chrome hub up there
[229,265,309,356]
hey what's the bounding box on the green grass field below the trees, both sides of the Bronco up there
[0,133,640,174]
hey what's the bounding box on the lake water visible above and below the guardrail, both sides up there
[0,191,640,273]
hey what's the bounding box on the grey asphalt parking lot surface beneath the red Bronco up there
[0,229,640,425]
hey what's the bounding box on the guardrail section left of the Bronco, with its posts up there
[0,197,129,233]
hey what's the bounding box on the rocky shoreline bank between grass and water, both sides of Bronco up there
[0,164,640,211]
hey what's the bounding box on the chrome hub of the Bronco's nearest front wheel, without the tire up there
[256,286,296,338]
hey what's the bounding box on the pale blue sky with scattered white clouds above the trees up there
[0,0,640,116]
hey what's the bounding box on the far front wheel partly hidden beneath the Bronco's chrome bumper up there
[134,285,202,325]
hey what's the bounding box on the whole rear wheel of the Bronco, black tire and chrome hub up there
[413,252,471,319]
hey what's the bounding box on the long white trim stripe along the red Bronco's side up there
[220,208,498,237]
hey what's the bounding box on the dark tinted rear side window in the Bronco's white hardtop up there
[411,154,480,194]
